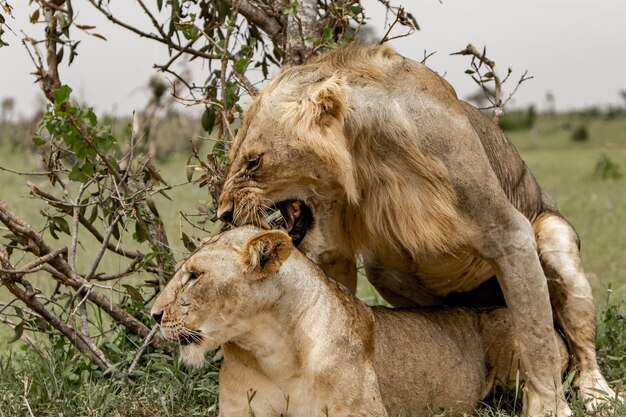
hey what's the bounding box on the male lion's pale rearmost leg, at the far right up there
[533,213,615,410]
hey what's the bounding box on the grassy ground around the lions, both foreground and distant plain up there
[0,112,626,417]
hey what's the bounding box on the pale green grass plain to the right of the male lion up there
[510,117,626,300]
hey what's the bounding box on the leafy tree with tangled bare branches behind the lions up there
[0,0,417,376]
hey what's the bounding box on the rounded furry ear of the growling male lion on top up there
[310,76,347,125]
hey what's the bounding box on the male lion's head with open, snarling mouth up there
[218,65,357,245]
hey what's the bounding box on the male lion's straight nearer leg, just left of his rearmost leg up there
[479,207,571,417]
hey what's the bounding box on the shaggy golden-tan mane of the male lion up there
[231,44,471,259]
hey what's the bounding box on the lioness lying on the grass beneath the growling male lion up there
[152,226,567,417]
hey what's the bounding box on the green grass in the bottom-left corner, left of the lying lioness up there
[0,345,219,417]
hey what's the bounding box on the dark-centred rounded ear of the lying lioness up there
[241,230,293,276]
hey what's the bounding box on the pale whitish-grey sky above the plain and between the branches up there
[0,0,626,118]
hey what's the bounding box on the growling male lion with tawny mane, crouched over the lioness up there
[218,45,615,417]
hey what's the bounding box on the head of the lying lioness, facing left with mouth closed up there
[151,226,293,365]
